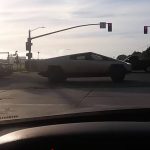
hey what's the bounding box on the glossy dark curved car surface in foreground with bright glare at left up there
[0,109,150,150]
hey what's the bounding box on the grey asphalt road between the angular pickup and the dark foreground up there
[0,72,150,118]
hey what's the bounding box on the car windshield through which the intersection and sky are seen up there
[0,0,150,122]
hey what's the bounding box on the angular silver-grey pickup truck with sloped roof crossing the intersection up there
[38,52,131,82]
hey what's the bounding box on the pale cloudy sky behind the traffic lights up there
[0,0,150,58]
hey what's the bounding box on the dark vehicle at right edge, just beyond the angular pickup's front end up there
[125,56,150,72]
